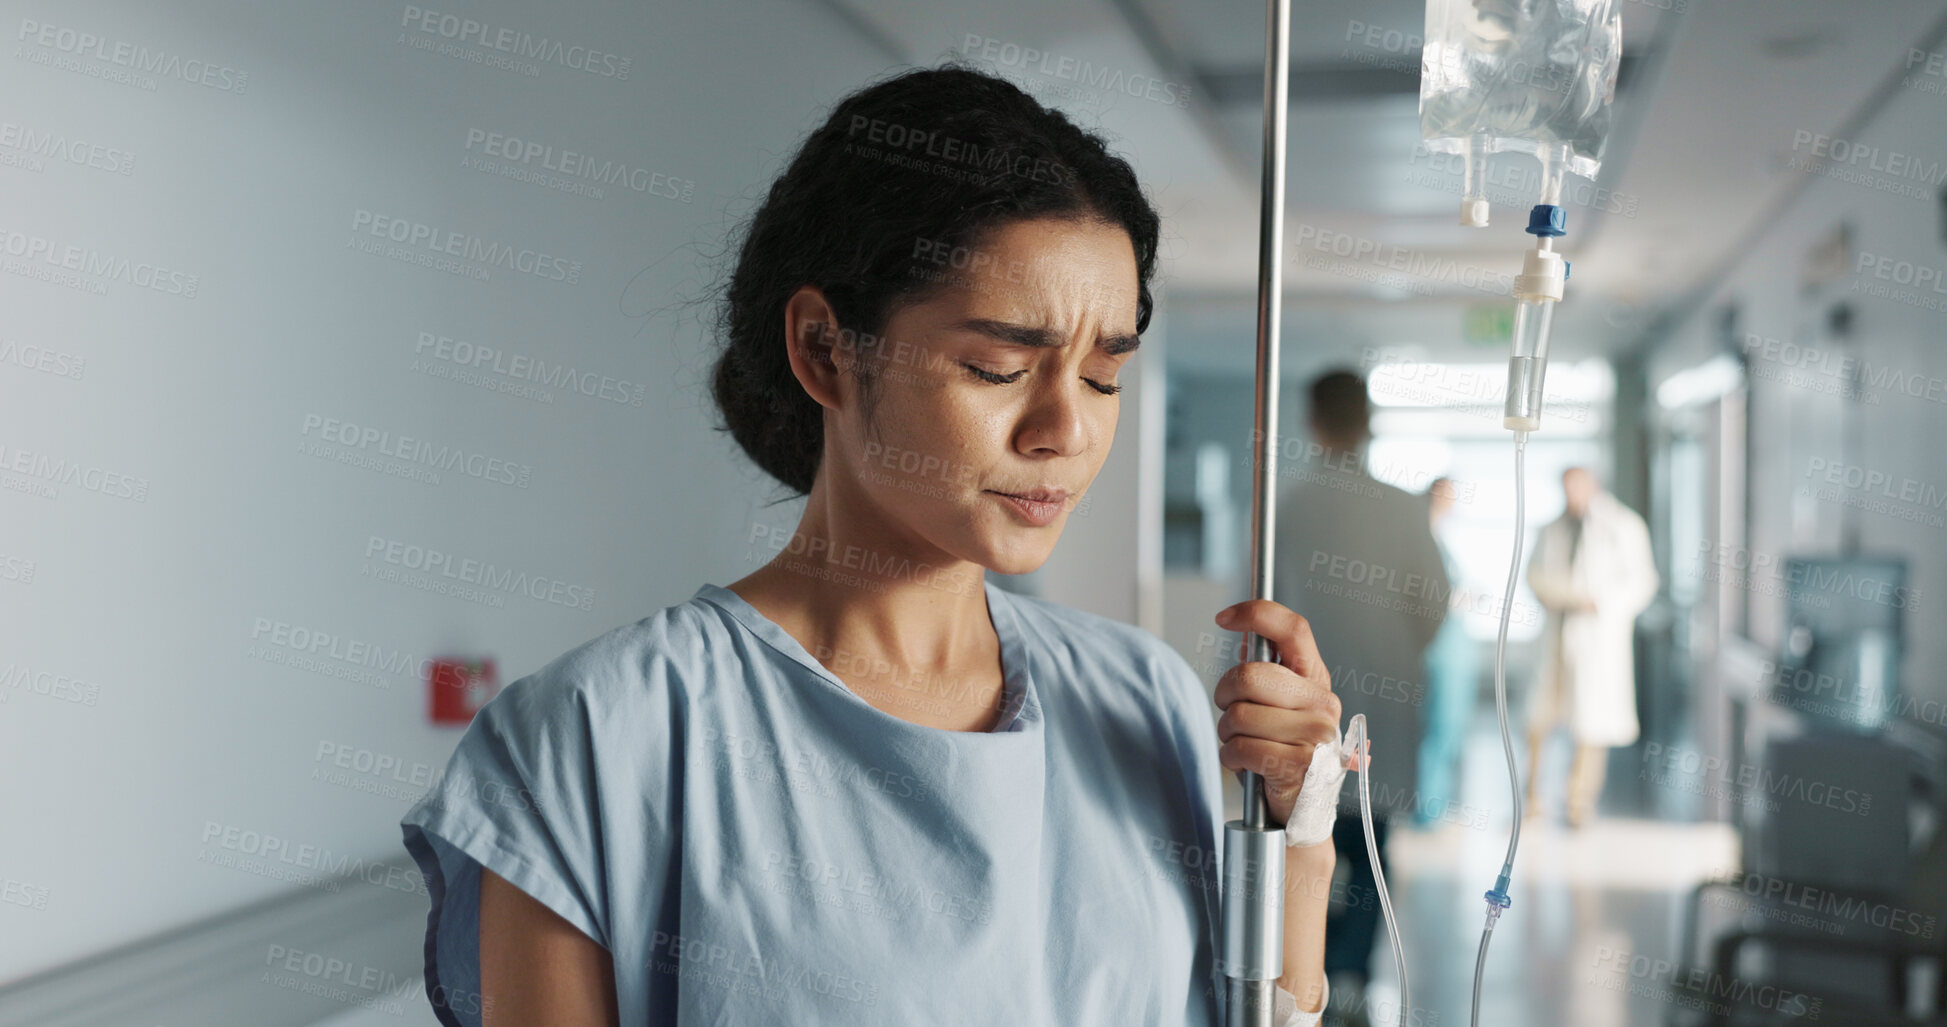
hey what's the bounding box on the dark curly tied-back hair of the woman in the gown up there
[711,64,1160,495]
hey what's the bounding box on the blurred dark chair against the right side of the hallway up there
[1671,725,1947,1027]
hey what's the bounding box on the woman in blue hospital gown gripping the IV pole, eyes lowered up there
[403,68,1338,1027]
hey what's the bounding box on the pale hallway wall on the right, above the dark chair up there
[1649,55,1947,731]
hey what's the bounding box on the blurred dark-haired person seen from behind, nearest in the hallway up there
[1273,370,1449,1025]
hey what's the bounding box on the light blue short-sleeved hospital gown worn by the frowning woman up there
[401,583,1225,1027]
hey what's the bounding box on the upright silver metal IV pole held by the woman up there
[1219,0,1291,1027]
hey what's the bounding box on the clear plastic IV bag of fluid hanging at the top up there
[1419,0,1622,224]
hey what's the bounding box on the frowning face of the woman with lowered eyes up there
[822,218,1139,575]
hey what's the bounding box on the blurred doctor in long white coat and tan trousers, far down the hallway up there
[1526,468,1659,826]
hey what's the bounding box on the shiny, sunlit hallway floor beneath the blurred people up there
[1227,711,1737,1027]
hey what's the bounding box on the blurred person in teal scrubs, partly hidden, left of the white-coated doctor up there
[1414,477,1480,828]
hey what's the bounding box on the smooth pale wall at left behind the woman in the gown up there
[0,0,888,980]
